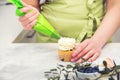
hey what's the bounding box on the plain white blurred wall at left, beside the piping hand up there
[0,5,23,47]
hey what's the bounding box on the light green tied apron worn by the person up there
[36,0,104,43]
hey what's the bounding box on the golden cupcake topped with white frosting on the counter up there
[58,38,76,62]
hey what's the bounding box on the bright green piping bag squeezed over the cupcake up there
[8,0,60,39]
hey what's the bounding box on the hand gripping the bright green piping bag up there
[19,1,40,30]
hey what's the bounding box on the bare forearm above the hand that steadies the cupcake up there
[92,0,120,47]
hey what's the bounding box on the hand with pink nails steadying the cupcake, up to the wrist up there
[71,38,102,63]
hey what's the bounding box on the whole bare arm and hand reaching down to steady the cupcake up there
[71,0,120,63]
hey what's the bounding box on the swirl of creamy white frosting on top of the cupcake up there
[58,37,76,50]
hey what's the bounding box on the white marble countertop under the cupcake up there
[0,43,120,80]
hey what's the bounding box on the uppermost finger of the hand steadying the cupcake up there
[72,40,88,57]
